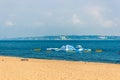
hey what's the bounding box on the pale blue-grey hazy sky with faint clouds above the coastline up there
[0,0,120,38]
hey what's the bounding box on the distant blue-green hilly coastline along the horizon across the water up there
[1,35,120,40]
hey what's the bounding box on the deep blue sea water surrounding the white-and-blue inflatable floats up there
[0,40,120,63]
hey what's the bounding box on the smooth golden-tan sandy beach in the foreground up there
[0,56,120,80]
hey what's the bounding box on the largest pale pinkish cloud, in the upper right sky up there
[82,5,118,27]
